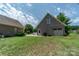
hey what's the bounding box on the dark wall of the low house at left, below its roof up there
[0,24,22,36]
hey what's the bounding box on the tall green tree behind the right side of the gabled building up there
[57,13,71,35]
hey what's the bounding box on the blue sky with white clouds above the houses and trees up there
[0,3,79,27]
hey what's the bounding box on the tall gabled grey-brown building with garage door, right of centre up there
[37,13,65,35]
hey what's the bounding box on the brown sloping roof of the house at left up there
[0,15,23,28]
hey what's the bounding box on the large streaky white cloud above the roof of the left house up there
[0,4,38,26]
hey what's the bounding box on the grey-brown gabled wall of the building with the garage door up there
[37,15,65,35]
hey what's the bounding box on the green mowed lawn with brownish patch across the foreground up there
[0,33,79,56]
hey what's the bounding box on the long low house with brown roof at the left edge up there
[0,15,23,36]
